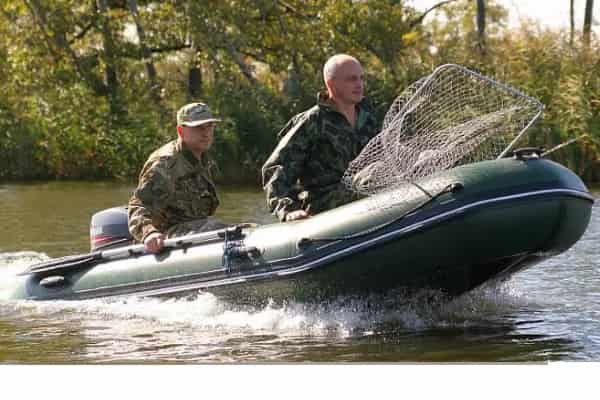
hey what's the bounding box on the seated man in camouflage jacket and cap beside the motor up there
[128,103,225,253]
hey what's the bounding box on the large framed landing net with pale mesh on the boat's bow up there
[342,64,543,195]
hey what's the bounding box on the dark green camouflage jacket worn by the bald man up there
[262,94,379,221]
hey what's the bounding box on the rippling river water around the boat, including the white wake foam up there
[0,183,600,363]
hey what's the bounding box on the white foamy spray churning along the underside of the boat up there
[0,289,519,337]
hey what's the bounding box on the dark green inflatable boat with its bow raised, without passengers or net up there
[1,150,594,301]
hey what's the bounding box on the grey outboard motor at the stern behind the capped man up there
[90,207,133,251]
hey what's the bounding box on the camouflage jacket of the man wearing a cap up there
[128,140,219,242]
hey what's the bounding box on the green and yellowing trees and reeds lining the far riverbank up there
[0,0,600,182]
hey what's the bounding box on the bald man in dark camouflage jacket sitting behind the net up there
[262,54,379,221]
